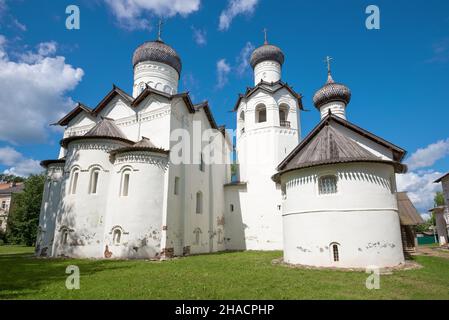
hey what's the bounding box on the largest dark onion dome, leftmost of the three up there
[133,40,182,74]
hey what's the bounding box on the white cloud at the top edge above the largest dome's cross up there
[104,0,201,30]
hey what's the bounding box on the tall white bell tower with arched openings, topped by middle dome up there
[231,30,302,250]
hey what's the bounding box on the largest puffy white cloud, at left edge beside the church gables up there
[0,36,84,144]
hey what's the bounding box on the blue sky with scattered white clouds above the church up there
[0,0,449,211]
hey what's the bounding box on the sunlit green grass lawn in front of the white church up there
[0,246,449,299]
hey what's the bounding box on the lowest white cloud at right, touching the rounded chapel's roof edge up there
[397,170,442,213]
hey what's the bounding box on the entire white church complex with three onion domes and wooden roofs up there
[36,31,406,268]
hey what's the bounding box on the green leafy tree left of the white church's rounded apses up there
[6,175,45,246]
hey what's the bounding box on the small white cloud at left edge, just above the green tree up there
[0,147,43,177]
